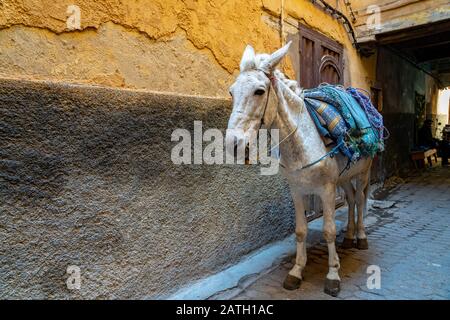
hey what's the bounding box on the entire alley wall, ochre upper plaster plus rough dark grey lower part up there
[0,0,375,299]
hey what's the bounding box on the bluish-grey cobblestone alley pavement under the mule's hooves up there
[235,167,450,300]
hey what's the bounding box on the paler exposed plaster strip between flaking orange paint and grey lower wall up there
[0,23,234,96]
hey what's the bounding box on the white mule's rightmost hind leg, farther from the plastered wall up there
[355,170,370,250]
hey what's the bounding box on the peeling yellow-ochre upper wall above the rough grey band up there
[0,0,376,97]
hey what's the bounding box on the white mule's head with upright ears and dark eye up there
[226,42,291,158]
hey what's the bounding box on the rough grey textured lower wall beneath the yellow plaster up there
[0,80,294,299]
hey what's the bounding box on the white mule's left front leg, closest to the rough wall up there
[283,190,308,290]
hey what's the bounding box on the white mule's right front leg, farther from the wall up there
[320,185,341,297]
